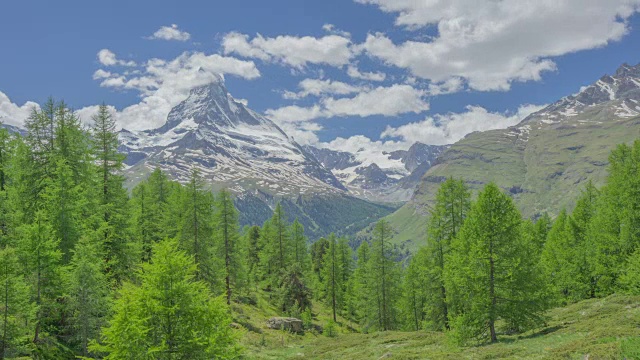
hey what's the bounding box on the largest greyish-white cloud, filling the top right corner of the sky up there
[357,0,640,91]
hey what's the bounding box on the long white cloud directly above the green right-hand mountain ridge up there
[380,105,545,145]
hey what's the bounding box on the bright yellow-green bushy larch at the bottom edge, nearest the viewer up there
[93,240,240,359]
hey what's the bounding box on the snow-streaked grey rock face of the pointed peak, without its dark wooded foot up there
[120,78,346,196]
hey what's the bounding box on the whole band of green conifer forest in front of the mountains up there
[0,100,640,359]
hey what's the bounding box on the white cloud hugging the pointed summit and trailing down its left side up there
[92,52,260,130]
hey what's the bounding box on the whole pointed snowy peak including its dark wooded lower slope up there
[120,77,395,239]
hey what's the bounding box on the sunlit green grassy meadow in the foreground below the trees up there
[243,295,640,360]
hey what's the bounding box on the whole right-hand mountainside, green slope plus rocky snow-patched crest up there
[389,64,640,248]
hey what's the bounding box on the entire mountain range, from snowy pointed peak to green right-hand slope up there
[10,64,640,246]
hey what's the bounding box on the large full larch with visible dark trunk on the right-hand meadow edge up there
[445,184,546,342]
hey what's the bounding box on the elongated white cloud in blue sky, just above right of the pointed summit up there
[222,32,354,69]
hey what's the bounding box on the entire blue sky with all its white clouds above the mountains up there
[0,0,640,150]
